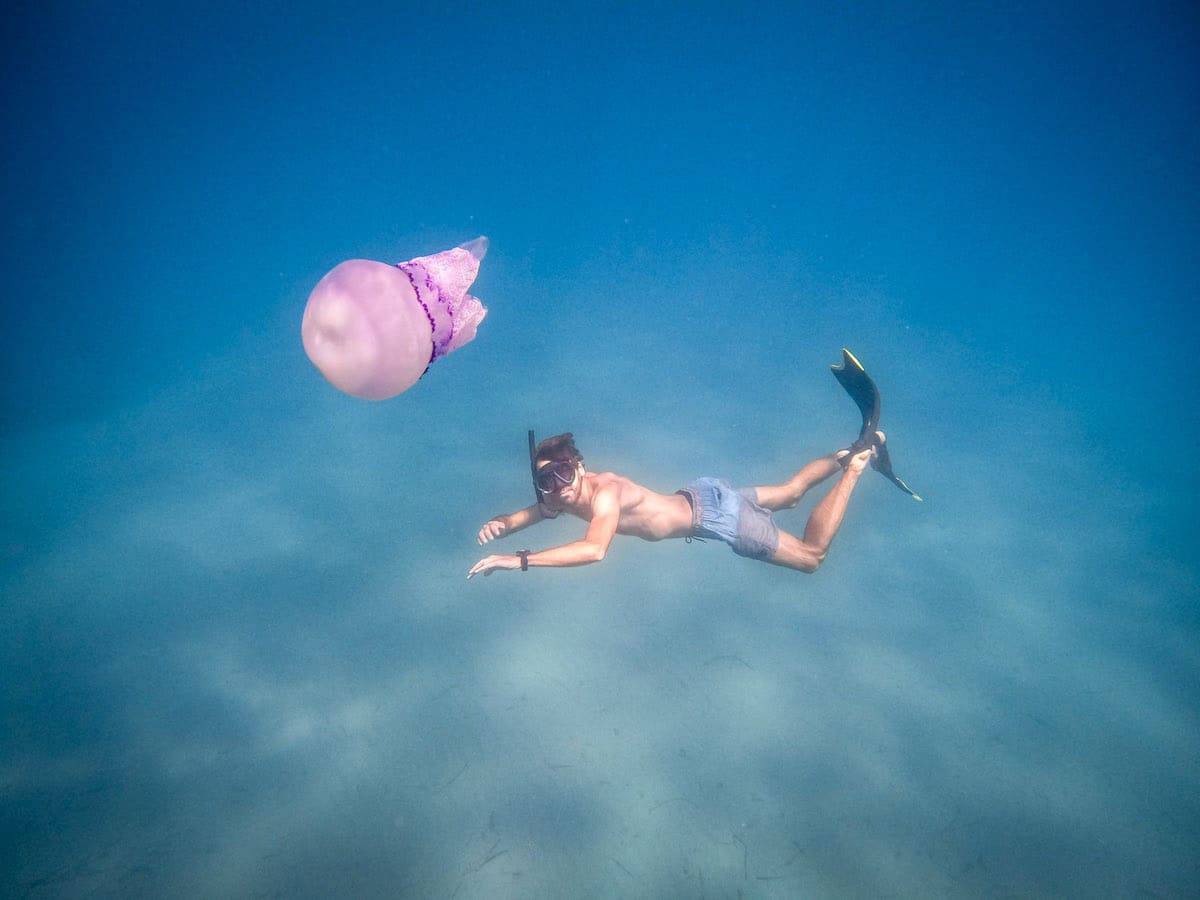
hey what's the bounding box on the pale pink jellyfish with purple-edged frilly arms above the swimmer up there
[300,238,487,400]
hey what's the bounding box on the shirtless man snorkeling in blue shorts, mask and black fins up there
[467,350,920,578]
